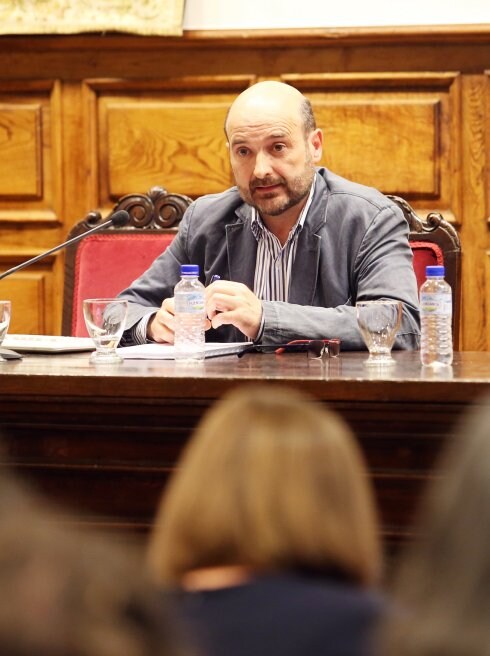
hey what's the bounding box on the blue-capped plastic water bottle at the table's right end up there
[420,266,453,367]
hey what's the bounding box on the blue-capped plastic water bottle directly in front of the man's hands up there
[174,264,205,362]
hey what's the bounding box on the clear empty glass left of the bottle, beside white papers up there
[83,298,128,364]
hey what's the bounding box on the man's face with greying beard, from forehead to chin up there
[228,111,321,217]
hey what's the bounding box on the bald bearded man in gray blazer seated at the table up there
[120,81,420,349]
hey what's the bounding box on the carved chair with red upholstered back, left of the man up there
[62,187,192,337]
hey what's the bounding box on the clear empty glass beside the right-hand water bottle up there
[356,300,402,365]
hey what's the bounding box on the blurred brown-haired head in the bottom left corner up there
[0,477,189,656]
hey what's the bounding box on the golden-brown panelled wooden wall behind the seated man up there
[0,26,490,350]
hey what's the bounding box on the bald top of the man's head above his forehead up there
[225,80,316,137]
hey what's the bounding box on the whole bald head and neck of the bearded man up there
[221,81,323,224]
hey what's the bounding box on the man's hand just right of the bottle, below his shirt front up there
[206,280,262,340]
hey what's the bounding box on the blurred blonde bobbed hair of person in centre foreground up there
[149,386,380,585]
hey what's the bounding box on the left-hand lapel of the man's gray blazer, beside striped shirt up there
[226,205,257,290]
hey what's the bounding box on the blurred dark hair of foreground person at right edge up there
[380,397,490,656]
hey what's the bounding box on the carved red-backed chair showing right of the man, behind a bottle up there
[388,196,461,349]
